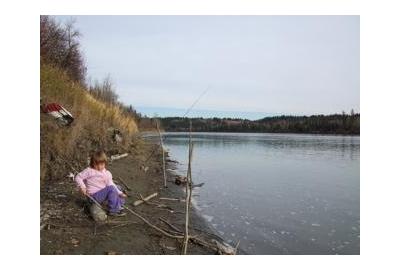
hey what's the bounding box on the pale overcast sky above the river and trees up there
[58,16,360,119]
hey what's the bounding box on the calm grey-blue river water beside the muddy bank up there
[156,133,360,254]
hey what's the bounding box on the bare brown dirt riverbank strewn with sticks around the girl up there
[40,136,222,254]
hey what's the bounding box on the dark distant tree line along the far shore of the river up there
[161,110,360,135]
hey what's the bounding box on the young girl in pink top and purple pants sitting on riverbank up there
[75,151,126,216]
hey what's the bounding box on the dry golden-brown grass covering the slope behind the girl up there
[40,64,138,182]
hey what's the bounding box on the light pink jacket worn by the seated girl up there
[75,167,122,195]
